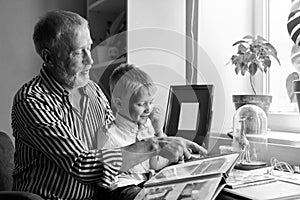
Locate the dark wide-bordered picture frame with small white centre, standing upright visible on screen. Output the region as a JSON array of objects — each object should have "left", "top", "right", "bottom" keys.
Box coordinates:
[{"left": 164, "top": 84, "right": 214, "bottom": 145}]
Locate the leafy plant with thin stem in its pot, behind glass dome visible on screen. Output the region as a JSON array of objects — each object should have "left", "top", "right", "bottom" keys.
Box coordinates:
[{"left": 229, "top": 35, "right": 280, "bottom": 114}]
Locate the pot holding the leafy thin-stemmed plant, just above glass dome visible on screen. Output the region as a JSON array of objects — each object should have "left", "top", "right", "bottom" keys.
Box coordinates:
[{"left": 232, "top": 95, "right": 274, "bottom": 115}]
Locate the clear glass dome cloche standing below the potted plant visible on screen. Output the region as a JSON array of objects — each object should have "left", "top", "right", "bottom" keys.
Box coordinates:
[{"left": 232, "top": 104, "right": 268, "bottom": 166}]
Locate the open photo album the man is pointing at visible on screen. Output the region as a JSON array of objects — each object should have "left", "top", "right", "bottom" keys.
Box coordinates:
[{"left": 135, "top": 153, "right": 239, "bottom": 200}]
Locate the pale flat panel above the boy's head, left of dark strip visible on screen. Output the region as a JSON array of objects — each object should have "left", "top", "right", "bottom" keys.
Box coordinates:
[{"left": 127, "top": 0, "right": 186, "bottom": 113}]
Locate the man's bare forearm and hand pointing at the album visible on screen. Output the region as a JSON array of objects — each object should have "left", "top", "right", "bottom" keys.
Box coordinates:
[{"left": 121, "top": 137, "right": 207, "bottom": 171}]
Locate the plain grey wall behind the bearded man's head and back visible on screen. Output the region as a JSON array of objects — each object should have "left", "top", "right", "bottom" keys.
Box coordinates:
[{"left": 0, "top": 0, "right": 86, "bottom": 141}]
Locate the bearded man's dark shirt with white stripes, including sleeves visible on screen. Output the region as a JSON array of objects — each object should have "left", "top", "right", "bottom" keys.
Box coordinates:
[{"left": 12, "top": 68, "right": 122, "bottom": 199}]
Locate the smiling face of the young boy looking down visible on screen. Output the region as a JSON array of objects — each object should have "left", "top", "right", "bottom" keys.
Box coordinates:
[{"left": 119, "top": 88, "right": 155, "bottom": 124}]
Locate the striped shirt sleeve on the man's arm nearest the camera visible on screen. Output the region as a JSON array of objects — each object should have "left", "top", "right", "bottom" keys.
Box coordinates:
[{"left": 12, "top": 97, "right": 122, "bottom": 185}]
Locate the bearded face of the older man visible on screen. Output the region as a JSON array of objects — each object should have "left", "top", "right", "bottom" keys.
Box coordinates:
[{"left": 56, "top": 27, "right": 93, "bottom": 89}]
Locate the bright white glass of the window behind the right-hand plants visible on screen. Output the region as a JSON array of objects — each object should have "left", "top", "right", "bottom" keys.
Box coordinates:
[{"left": 269, "top": 0, "right": 298, "bottom": 112}]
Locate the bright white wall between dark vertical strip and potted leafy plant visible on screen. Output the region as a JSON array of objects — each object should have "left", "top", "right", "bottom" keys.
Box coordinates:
[{"left": 198, "top": 0, "right": 253, "bottom": 131}]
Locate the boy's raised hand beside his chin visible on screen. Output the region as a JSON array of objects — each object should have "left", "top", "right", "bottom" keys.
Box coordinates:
[{"left": 149, "top": 105, "right": 164, "bottom": 137}]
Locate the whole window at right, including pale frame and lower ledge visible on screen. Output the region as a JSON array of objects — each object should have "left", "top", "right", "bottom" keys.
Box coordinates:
[{"left": 262, "top": 0, "right": 300, "bottom": 132}]
